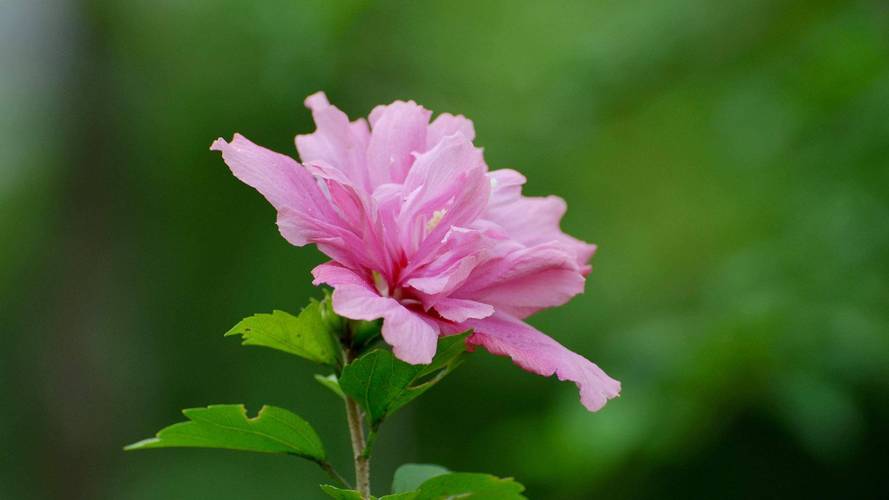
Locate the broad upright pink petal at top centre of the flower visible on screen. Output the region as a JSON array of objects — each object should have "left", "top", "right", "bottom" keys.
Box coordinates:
[{"left": 367, "top": 101, "right": 432, "bottom": 187}]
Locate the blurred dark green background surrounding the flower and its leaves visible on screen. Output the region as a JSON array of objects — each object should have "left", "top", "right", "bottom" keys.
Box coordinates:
[{"left": 0, "top": 0, "right": 889, "bottom": 499}]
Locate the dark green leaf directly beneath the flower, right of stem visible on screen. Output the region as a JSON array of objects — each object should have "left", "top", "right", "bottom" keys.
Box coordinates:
[{"left": 340, "top": 334, "right": 468, "bottom": 428}]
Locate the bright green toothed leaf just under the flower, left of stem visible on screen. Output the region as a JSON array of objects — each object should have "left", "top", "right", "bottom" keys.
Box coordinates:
[{"left": 225, "top": 299, "right": 339, "bottom": 366}]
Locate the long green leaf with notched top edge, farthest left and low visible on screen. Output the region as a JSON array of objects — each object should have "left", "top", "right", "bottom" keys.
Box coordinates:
[{"left": 124, "top": 405, "right": 325, "bottom": 462}]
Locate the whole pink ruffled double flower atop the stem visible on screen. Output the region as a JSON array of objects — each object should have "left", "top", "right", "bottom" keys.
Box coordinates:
[{"left": 210, "top": 92, "right": 620, "bottom": 411}]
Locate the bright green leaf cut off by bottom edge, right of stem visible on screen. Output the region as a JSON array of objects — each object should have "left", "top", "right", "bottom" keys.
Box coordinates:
[{"left": 414, "top": 472, "right": 525, "bottom": 500}]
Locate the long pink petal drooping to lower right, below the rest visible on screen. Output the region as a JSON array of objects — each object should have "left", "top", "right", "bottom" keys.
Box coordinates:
[{"left": 464, "top": 313, "right": 620, "bottom": 411}]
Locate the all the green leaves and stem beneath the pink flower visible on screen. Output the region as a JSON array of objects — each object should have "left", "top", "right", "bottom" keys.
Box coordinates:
[{"left": 124, "top": 296, "right": 492, "bottom": 500}]
